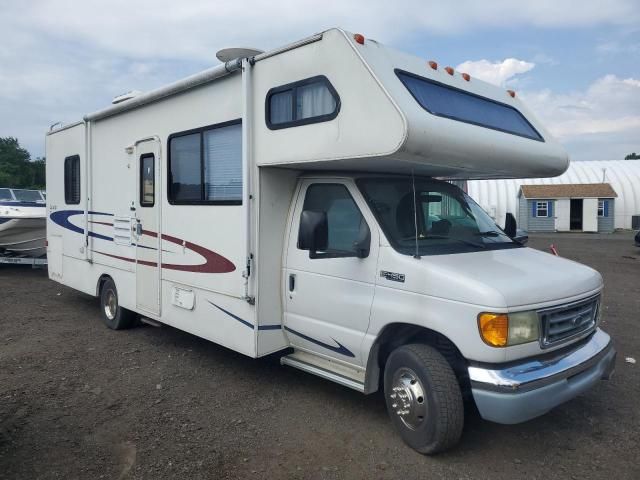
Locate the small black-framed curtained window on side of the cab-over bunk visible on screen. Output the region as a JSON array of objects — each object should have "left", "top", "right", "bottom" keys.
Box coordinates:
[{"left": 265, "top": 75, "right": 340, "bottom": 130}]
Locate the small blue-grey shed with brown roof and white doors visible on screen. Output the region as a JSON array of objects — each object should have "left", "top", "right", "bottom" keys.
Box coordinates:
[{"left": 518, "top": 183, "right": 618, "bottom": 233}]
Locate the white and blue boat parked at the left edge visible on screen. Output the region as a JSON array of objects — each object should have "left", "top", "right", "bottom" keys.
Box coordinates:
[{"left": 0, "top": 187, "right": 47, "bottom": 257}]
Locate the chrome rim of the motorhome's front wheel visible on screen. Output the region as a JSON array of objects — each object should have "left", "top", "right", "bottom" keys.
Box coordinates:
[{"left": 389, "top": 367, "right": 427, "bottom": 430}]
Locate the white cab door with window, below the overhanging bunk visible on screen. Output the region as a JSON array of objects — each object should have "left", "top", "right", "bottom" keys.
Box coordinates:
[{"left": 284, "top": 181, "right": 379, "bottom": 365}]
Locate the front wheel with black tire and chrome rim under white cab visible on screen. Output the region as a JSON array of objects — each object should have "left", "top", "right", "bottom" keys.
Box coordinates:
[{"left": 384, "top": 344, "right": 464, "bottom": 454}]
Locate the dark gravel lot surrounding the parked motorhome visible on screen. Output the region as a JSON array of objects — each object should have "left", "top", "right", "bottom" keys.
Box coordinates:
[{"left": 0, "top": 232, "right": 640, "bottom": 480}]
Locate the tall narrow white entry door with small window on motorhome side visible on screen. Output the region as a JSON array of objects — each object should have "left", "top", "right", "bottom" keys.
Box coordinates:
[{"left": 135, "top": 140, "right": 161, "bottom": 316}]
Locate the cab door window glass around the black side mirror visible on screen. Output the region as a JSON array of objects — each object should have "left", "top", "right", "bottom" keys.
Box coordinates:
[{"left": 303, "top": 183, "right": 369, "bottom": 258}]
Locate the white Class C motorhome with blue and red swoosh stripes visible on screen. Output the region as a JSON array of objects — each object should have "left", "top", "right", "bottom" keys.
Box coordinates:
[{"left": 47, "top": 29, "right": 615, "bottom": 453}]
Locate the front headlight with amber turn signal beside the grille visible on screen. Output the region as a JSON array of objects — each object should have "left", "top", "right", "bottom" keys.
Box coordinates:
[{"left": 478, "top": 311, "right": 540, "bottom": 347}]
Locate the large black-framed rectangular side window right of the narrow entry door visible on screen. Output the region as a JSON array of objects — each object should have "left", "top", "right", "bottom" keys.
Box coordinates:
[{"left": 168, "top": 120, "right": 242, "bottom": 205}]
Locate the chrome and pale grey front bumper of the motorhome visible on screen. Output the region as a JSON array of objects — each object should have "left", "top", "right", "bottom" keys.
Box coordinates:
[{"left": 469, "top": 328, "right": 616, "bottom": 424}]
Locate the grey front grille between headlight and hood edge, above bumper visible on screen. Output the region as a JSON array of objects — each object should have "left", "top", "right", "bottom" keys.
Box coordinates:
[{"left": 538, "top": 295, "right": 600, "bottom": 348}]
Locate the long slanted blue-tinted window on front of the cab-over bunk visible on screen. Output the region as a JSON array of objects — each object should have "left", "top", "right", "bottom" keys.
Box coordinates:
[{"left": 396, "top": 70, "right": 544, "bottom": 142}]
